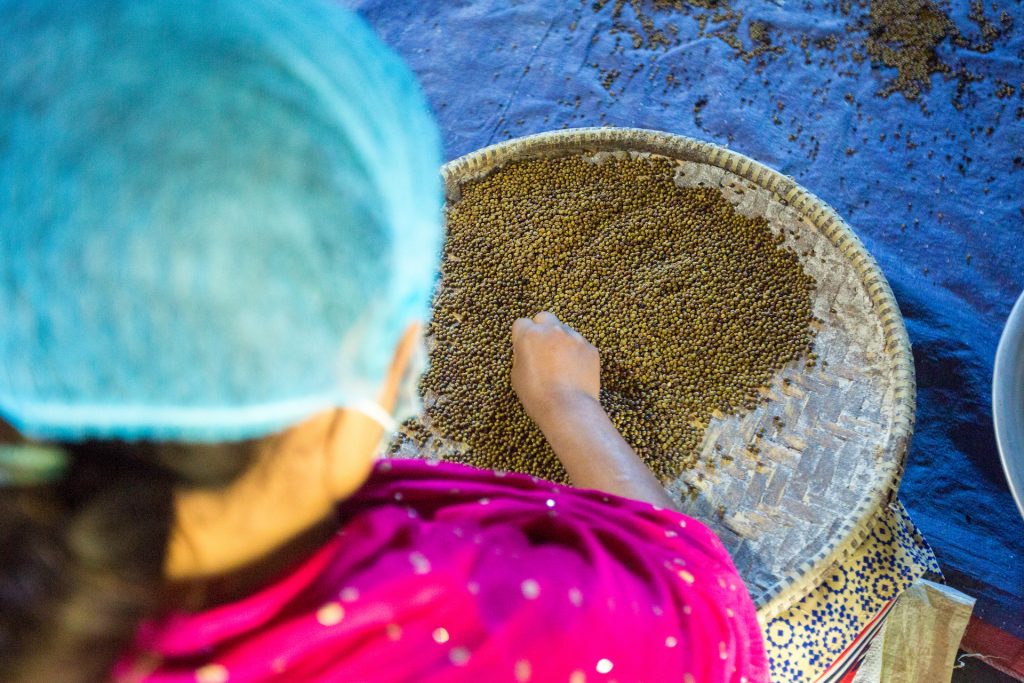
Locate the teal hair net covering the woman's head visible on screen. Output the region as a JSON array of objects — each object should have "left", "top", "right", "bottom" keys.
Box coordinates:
[{"left": 0, "top": 0, "right": 442, "bottom": 441}]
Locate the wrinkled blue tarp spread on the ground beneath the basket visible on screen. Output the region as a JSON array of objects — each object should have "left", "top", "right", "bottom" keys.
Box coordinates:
[{"left": 348, "top": 0, "right": 1024, "bottom": 637}]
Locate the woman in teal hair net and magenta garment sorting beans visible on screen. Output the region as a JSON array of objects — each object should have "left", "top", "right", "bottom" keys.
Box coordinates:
[{"left": 0, "top": 0, "right": 767, "bottom": 683}]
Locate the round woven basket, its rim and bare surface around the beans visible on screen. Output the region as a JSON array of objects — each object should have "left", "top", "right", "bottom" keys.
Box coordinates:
[{"left": 432, "top": 128, "right": 914, "bottom": 621}]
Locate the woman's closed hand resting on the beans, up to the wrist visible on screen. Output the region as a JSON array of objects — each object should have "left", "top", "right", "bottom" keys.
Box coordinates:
[{"left": 512, "top": 311, "right": 601, "bottom": 429}]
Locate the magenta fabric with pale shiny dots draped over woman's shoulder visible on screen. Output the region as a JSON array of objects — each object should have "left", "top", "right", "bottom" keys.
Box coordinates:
[{"left": 115, "top": 460, "right": 768, "bottom": 683}]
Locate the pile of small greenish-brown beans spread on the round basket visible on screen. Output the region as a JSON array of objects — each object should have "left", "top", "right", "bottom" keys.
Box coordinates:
[{"left": 407, "top": 157, "right": 814, "bottom": 481}]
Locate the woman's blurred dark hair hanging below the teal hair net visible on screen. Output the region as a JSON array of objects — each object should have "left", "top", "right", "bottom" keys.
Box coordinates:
[{"left": 0, "top": 424, "right": 256, "bottom": 683}]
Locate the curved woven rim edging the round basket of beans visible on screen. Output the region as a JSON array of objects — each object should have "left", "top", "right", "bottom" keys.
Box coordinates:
[{"left": 441, "top": 127, "right": 916, "bottom": 623}]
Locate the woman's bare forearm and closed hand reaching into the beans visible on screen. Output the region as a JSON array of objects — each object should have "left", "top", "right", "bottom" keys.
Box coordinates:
[{"left": 512, "top": 311, "right": 675, "bottom": 508}]
